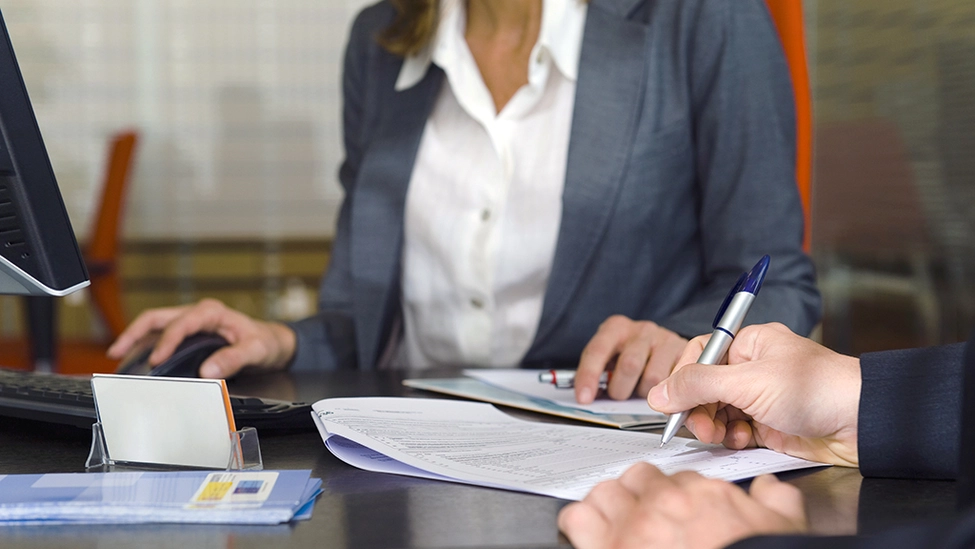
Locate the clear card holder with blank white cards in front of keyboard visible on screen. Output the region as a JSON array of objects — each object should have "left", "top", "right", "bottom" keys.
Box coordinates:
[{"left": 85, "top": 374, "right": 263, "bottom": 471}]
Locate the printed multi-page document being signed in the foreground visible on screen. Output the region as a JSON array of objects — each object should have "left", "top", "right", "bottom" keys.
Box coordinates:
[{"left": 312, "top": 397, "right": 822, "bottom": 500}]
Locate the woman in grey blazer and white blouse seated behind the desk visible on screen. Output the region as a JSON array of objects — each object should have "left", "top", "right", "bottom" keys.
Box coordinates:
[{"left": 110, "top": 0, "right": 820, "bottom": 400}]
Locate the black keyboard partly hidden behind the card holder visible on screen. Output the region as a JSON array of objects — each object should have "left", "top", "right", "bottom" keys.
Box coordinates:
[{"left": 0, "top": 368, "right": 315, "bottom": 432}]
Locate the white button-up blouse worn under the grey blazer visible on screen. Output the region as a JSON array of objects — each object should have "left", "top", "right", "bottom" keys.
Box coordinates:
[{"left": 393, "top": 0, "right": 586, "bottom": 368}]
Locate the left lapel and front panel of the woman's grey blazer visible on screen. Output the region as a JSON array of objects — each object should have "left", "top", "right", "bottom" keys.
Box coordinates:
[{"left": 350, "top": 60, "right": 443, "bottom": 369}]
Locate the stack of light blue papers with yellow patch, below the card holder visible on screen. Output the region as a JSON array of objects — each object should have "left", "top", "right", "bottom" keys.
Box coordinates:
[{"left": 0, "top": 470, "right": 322, "bottom": 525}]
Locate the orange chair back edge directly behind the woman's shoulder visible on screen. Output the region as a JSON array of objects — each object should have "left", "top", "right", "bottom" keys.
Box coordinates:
[{"left": 765, "top": 0, "right": 813, "bottom": 252}]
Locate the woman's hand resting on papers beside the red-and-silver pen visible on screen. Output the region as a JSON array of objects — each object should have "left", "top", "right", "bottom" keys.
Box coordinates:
[{"left": 575, "top": 315, "right": 687, "bottom": 404}]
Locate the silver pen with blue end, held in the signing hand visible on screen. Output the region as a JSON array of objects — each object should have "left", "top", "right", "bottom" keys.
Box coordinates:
[{"left": 660, "top": 255, "right": 769, "bottom": 446}]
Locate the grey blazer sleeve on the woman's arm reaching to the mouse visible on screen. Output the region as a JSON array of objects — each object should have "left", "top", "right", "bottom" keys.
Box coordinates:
[{"left": 290, "top": 4, "right": 392, "bottom": 370}]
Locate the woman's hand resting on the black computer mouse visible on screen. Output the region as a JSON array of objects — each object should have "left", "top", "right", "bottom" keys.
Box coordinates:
[{"left": 108, "top": 299, "right": 295, "bottom": 378}]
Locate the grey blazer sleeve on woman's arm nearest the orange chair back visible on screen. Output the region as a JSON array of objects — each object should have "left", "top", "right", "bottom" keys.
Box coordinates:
[{"left": 658, "top": 0, "right": 820, "bottom": 336}]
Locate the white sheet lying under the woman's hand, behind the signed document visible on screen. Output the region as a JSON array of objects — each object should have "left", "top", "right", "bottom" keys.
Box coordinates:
[{"left": 464, "top": 368, "right": 667, "bottom": 416}]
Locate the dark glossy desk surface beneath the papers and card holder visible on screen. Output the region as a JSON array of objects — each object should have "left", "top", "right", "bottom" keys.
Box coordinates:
[{"left": 0, "top": 372, "right": 954, "bottom": 549}]
